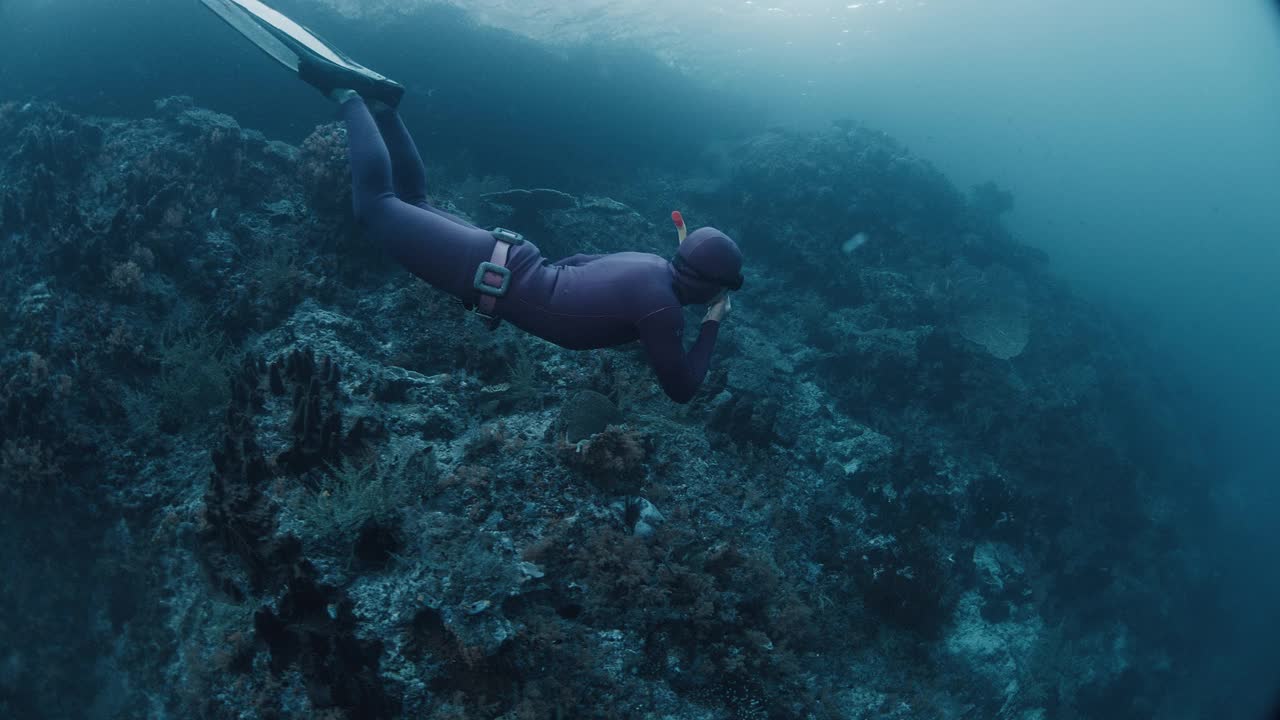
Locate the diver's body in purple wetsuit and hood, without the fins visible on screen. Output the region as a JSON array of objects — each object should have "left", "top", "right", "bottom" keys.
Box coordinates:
[{"left": 340, "top": 90, "right": 741, "bottom": 402}]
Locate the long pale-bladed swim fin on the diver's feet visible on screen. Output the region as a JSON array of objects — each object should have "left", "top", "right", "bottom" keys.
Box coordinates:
[{"left": 201, "top": 0, "right": 404, "bottom": 108}]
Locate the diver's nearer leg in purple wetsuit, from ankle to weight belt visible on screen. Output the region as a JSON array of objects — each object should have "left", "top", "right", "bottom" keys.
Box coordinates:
[{"left": 342, "top": 97, "right": 494, "bottom": 301}]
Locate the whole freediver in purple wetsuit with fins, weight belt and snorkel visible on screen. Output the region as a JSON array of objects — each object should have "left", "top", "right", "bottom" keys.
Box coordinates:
[{"left": 205, "top": 0, "right": 742, "bottom": 402}]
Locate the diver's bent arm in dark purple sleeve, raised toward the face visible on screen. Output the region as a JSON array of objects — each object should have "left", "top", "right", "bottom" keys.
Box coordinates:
[{"left": 639, "top": 306, "right": 719, "bottom": 404}]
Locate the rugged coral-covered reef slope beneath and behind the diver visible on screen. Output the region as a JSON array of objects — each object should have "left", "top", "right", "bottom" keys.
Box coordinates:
[{"left": 0, "top": 99, "right": 1212, "bottom": 720}]
